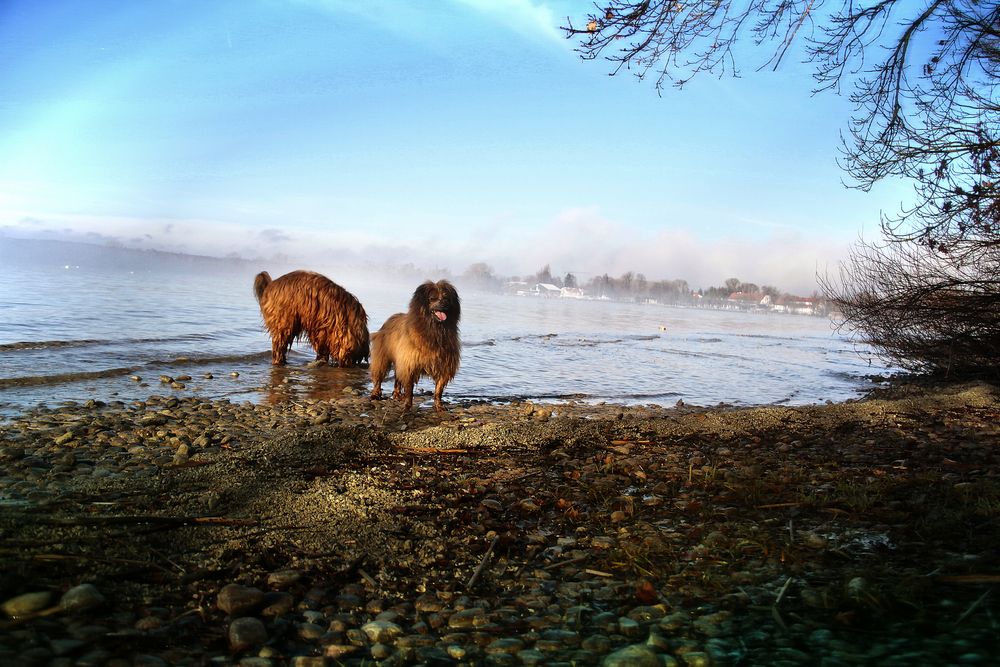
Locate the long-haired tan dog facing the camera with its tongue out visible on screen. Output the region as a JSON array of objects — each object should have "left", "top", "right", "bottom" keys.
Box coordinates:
[{"left": 371, "top": 280, "right": 462, "bottom": 412}]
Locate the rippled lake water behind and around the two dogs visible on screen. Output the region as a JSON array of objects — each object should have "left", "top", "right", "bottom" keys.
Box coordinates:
[{"left": 0, "top": 238, "right": 887, "bottom": 415}]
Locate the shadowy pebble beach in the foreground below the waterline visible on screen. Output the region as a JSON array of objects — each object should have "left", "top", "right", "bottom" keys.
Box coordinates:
[{"left": 0, "top": 384, "right": 1000, "bottom": 667}]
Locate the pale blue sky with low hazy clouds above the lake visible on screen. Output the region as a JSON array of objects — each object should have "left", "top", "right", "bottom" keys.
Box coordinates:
[{"left": 0, "top": 0, "right": 907, "bottom": 294}]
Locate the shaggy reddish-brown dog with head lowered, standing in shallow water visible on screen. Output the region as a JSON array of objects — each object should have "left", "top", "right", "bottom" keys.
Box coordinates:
[{"left": 253, "top": 271, "right": 368, "bottom": 368}]
